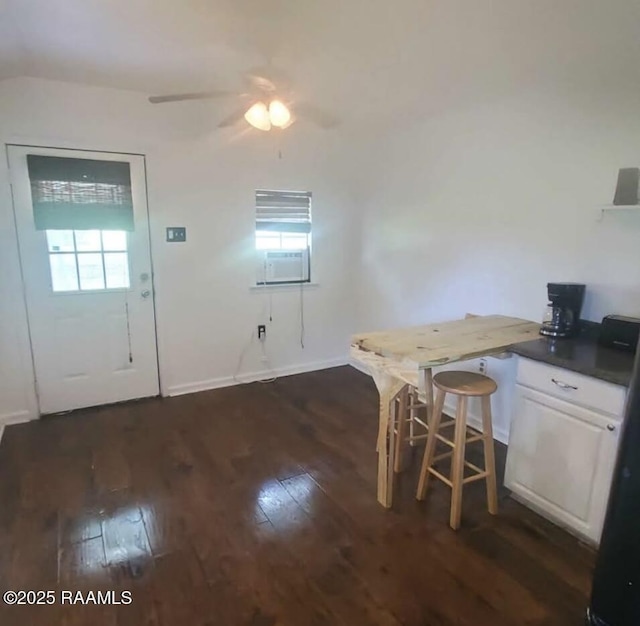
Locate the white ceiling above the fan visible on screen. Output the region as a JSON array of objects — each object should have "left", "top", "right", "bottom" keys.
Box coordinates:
[{"left": 0, "top": 0, "right": 640, "bottom": 127}]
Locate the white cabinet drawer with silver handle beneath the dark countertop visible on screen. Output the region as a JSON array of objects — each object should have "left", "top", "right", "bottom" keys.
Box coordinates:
[{"left": 517, "top": 357, "right": 626, "bottom": 418}]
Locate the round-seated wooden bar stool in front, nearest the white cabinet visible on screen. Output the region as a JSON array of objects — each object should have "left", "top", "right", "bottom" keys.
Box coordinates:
[{"left": 416, "top": 371, "right": 498, "bottom": 530}]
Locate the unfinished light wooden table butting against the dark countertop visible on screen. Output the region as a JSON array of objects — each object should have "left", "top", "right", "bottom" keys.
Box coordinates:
[{"left": 351, "top": 315, "right": 540, "bottom": 508}]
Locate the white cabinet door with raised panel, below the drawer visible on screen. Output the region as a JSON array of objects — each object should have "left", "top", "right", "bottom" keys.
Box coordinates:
[{"left": 505, "top": 385, "right": 620, "bottom": 542}]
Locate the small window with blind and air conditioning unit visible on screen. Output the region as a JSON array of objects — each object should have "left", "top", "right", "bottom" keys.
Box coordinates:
[{"left": 256, "top": 189, "right": 311, "bottom": 284}]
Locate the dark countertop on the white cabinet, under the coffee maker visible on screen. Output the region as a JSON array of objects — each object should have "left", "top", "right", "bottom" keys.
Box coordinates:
[{"left": 509, "top": 337, "right": 634, "bottom": 387}]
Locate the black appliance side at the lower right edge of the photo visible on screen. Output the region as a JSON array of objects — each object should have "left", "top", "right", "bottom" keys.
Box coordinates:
[{"left": 587, "top": 342, "right": 640, "bottom": 626}]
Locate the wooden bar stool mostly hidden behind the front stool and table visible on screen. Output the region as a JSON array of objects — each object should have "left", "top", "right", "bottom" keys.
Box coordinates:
[{"left": 393, "top": 369, "right": 433, "bottom": 473}]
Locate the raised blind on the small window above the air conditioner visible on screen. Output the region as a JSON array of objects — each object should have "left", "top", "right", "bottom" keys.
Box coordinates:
[{"left": 256, "top": 190, "right": 311, "bottom": 233}]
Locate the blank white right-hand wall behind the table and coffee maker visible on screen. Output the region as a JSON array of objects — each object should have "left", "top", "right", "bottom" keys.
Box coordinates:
[{"left": 358, "top": 93, "right": 640, "bottom": 329}]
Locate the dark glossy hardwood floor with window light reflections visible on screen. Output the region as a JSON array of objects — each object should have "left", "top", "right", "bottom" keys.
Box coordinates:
[{"left": 0, "top": 367, "right": 594, "bottom": 626}]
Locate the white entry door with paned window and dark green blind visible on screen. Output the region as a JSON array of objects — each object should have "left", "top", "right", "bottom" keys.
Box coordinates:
[{"left": 8, "top": 146, "right": 159, "bottom": 414}]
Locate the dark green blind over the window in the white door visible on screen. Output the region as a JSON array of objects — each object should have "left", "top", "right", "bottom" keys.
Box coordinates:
[{"left": 27, "top": 154, "right": 134, "bottom": 231}]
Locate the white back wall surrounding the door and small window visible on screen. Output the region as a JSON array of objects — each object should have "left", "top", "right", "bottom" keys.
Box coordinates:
[{"left": 0, "top": 79, "right": 356, "bottom": 423}]
